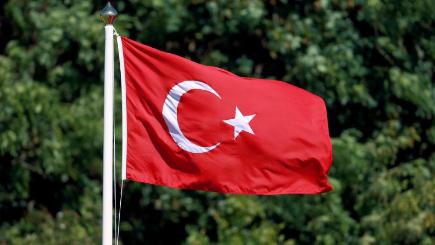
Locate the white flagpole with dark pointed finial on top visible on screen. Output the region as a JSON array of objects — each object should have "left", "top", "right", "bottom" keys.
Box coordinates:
[{"left": 100, "top": 2, "right": 118, "bottom": 245}]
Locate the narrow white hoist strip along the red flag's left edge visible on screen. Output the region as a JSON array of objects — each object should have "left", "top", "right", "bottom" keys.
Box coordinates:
[{"left": 116, "top": 35, "right": 127, "bottom": 180}]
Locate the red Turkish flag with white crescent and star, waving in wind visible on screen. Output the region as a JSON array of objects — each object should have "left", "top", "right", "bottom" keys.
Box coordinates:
[{"left": 117, "top": 37, "right": 332, "bottom": 195}]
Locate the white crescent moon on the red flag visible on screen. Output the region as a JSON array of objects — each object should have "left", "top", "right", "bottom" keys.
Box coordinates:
[{"left": 162, "top": 81, "right": 221, "bottom": 153}]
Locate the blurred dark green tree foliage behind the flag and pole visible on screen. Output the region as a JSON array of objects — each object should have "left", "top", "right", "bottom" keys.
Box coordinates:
[{"left": 0, "top": 0, "right": 435, "bottom": 244}]
